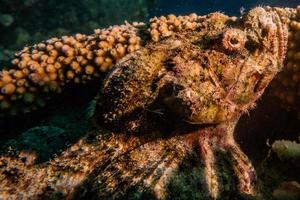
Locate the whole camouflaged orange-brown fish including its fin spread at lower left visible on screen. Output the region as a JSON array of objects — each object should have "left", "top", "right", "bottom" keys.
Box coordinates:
[{"left": 0, "top": 8, "right": 294, "bottom": 199}]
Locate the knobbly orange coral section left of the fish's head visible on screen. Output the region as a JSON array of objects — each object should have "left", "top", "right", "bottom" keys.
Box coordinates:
[{"left": 0, "top": 23, "right": 142, "bottom": 114}]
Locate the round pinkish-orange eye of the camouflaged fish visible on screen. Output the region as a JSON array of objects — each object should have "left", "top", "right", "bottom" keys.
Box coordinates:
[{"left": 222, "top": 28, "right": 247, "bottom": 51}]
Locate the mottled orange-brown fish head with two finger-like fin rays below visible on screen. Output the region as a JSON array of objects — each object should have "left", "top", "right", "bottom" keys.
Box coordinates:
[{"left": 102, "top": 7, "right": 288, "bottom": 198}]
